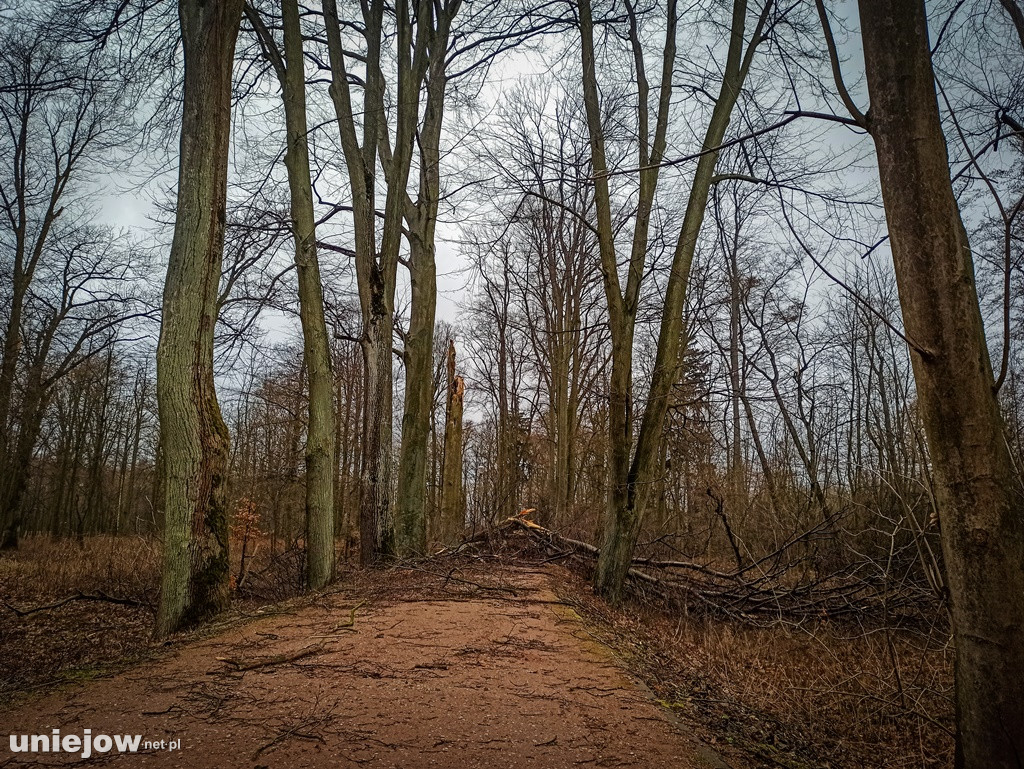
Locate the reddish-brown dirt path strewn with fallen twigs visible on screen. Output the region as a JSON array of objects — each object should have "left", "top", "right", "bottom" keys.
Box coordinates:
[{"left": 0, "top": 569, "right": 726, "bottom": 769}]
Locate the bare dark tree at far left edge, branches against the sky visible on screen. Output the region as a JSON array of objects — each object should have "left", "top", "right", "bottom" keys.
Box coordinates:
[{"left": 0, "top": 7, "right": 144, "bottom": 547}]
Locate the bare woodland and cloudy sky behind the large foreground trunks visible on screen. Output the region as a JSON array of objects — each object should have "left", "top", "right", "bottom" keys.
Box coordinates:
[{"left": 0, "top": 0, "right": 1024, "bottom": 764}]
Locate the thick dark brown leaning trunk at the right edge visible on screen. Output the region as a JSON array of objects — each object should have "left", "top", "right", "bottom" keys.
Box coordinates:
[{"left": 860, "top": 0, "right": 1024, "bottom": 769}]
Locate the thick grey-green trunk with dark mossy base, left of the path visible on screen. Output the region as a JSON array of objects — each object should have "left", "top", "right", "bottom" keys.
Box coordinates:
[{"left": 155, "top": 0, "right": 243, "bottom": 637}]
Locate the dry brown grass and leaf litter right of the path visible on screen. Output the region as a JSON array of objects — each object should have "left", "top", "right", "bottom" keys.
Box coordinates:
[{"left": 566, "top": 575, "right": 952, "bottom": 769}]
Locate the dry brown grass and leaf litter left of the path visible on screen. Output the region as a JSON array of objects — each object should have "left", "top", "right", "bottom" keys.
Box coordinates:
[{"left": 0, "top": 536, "right": 301, "bottom": 702}]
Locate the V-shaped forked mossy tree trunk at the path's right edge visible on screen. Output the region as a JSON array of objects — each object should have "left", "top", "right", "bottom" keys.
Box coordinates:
[{"left": 580, "top": 0, "right": 772, "bottom": 602}]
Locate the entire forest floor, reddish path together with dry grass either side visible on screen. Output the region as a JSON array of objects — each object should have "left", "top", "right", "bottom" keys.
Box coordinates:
[{"left": 0, "top": 537, "right": 952, "bottom": 769}]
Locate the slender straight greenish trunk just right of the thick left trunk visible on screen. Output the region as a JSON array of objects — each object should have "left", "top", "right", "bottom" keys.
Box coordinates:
[{"left": 281, "top": 0, "right": 336, "bottom": 590}]
